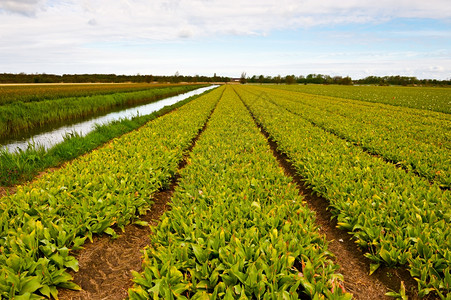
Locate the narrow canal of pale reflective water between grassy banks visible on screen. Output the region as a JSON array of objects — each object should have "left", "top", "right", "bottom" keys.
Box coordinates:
[{"left": 0, "top": 85, "right": 217, "bottom": 152}]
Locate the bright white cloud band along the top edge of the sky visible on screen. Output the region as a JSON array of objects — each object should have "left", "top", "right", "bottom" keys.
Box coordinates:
[{"left": 0, "top": 0, "right": 451, "bottom": 39}]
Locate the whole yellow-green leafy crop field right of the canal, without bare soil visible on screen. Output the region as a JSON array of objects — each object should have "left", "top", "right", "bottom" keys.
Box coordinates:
[{"left": 0, "top": 85, "right": 451, "bottom": 299}]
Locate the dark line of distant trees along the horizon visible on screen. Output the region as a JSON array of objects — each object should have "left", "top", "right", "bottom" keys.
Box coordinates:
[{"left": 0, "top": 72, "right": 451, "bottom": 86}]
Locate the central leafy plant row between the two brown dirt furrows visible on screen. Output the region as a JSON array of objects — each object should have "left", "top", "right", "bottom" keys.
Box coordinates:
[{"left": 129, "top": 87, "right": 351, "bottom": 299}]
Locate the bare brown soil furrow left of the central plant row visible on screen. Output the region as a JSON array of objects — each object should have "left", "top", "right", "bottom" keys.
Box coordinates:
[{"left": 59, "top": 182, "right": 175, "bottom": 300}]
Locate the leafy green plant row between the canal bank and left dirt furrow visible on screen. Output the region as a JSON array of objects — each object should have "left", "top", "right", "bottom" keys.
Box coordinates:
[{"left": 0, "top": 89, "right": 222, "bottom": 299}]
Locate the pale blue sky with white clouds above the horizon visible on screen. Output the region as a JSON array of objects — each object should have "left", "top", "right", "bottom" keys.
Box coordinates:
[{"left": 0, "top": 0, "right": 451, "bottom": 79}]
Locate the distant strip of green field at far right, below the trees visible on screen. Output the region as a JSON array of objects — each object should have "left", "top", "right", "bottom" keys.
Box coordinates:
[{"left": 266, "top": 84, "right": 451, "bottom": 114}]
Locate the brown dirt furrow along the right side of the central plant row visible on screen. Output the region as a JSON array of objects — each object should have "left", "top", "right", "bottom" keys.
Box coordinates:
[{"left": 231, "top": 91, "right": 432, "bottom": 300}]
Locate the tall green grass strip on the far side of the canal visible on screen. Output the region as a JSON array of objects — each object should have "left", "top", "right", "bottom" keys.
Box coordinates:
[{"left": 0, "top": 85, "right": 202, "bottom": 138}]
